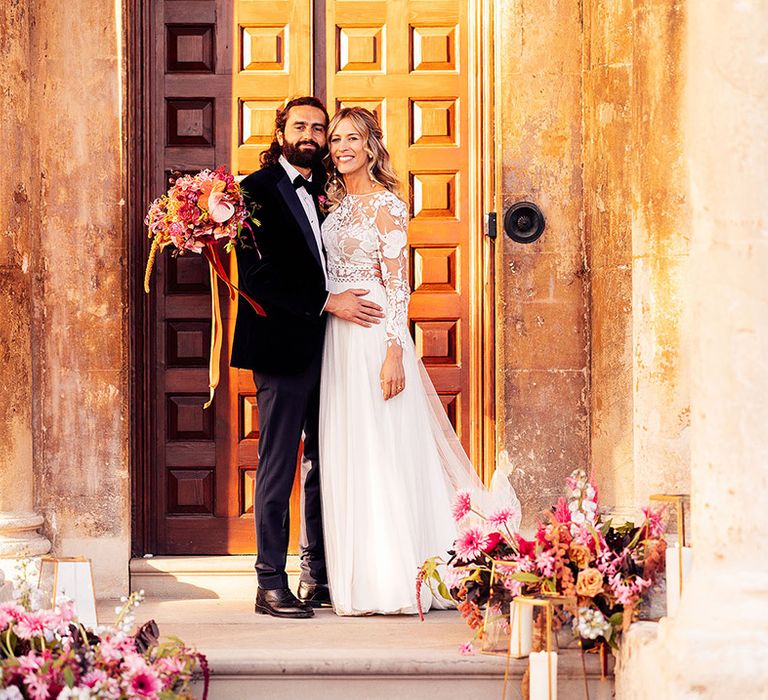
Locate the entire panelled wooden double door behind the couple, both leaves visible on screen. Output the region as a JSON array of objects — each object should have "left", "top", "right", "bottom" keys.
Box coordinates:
[{"left": 146, "top": 0, "right": 482, "bottom": 554}]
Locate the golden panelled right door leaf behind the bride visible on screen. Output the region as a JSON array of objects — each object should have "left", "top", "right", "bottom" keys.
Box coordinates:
[{"left": 326, "top": 0, "right": 479, "bottom": 457}]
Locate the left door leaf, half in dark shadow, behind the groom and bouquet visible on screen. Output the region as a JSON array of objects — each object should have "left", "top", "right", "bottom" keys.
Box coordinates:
[{"left": 148, "top": 0, "right": 312, "bottom": 554}]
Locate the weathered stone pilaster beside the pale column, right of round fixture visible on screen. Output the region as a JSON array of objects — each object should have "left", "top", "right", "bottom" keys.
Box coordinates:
[{"left": 584, "top": 0, "right": 690, "bottom": 512}]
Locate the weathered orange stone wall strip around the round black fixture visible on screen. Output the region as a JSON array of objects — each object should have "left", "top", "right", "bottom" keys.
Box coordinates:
[{"left": 496, "top": 0, "right": 589, "bottom": 524}]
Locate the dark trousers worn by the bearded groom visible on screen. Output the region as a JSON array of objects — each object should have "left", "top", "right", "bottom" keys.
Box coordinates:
[{"left": 253, "top": 354, "right": 328, "bottom": 588}]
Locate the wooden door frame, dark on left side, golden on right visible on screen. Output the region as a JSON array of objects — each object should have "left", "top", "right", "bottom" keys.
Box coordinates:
[{"left": 122, "top": 0, "right": 501, "bottom": 556}]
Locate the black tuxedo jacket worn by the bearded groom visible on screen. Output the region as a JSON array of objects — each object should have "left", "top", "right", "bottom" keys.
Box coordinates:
[{"left": 231, "top": 163, "right": 328, "bottom": 374}]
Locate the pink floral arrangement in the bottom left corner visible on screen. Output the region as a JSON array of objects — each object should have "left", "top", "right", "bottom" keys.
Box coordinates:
[{"left": 0, "top": 572, "right": 208, "bottom": 700}]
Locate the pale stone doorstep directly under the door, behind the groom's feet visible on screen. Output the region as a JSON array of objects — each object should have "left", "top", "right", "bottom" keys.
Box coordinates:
[{"left": 130, "top": 555, "right": 299, "bottom": 600}]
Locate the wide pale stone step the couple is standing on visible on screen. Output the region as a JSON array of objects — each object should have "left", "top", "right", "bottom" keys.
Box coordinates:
[{"left": 100, "top": 598, "right": 613, "bottom": 700}]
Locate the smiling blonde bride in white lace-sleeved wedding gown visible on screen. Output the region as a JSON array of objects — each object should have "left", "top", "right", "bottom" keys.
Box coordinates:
[{"left": 319, "top": 107, "right": 514, "bottom": 615}]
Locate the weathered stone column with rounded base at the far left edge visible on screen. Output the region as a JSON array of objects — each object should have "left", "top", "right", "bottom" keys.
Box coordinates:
[{"left": 0, "top": 3, "right": 50, "bottom": 558}]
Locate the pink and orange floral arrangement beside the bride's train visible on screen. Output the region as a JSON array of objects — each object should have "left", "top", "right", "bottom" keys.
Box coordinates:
[{"left": 417, "top": 470, "right": 666, "bottom": 652}]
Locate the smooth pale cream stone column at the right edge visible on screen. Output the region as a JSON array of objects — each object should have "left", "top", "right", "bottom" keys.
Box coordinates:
[{"left": 618, "top": 0, "right": 768, "bottom": 700}]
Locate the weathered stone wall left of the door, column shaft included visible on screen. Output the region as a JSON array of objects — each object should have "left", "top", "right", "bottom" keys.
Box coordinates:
[{"left": 0, "top": 0, "right": 130, "bottom": 594}]
